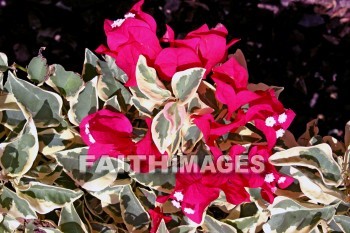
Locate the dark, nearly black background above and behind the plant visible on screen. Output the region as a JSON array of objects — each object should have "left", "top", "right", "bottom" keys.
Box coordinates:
[{"left": 0, "top": 0, "right": 350, "bottom": 138}]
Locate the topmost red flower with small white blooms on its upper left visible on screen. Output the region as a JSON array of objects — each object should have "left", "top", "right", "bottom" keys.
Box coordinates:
[{"left": 96, "top": 0, "right": 161, "bottom": 86}]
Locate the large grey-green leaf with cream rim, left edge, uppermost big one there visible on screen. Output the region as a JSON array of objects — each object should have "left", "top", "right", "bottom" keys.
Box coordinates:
[{"left": 5, "top": 72, "right": 63, "bottom": 128}]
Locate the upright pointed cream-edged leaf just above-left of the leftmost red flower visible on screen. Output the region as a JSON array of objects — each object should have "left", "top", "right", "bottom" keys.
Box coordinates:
[{"left": 68, "top": 77, "right": 98, "bottom": 126}]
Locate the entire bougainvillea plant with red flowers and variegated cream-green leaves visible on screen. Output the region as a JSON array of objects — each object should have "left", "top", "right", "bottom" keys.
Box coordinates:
[{"left": 0, "top": 1, "right": 350, "bottom": 233}]
